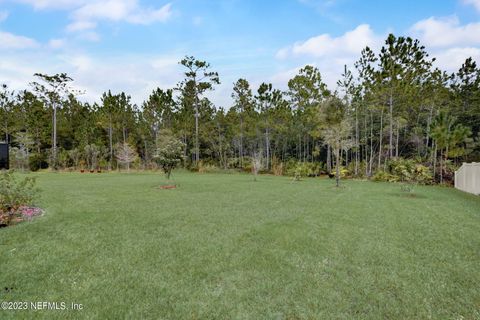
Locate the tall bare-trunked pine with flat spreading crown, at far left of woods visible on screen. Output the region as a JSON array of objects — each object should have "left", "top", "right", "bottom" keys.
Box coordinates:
[{"left": 31, "top": 73, "right": 78, "bottom": 169}]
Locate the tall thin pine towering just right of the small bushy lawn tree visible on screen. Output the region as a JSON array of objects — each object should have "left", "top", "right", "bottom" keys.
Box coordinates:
[{"left": 180, "top": 56, "right": 220, "bottom": 164}]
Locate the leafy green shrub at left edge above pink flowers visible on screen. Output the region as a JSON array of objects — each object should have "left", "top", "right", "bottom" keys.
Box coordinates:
[{"left": 0, "top": 171, "right": 38, "bottom": 226}]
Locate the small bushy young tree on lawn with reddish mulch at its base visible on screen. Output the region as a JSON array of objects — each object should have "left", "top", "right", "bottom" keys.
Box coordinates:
[{"left": 154, "top": 129, "right": 184, "bottom": 179}]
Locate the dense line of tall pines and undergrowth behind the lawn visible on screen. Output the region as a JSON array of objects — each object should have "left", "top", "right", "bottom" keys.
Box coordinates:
[{"left": 0, "top": 34, "right": 480, "bottom": 182}]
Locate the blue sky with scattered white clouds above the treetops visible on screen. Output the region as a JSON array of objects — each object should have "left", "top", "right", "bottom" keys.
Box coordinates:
[{"left": 0, "top": 0, "right": 480, "bottom": 108}]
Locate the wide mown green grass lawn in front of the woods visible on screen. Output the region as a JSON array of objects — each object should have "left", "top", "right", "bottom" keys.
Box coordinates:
[{"left": 0, "top": 173, "right": 480, "bottom": 319}]
